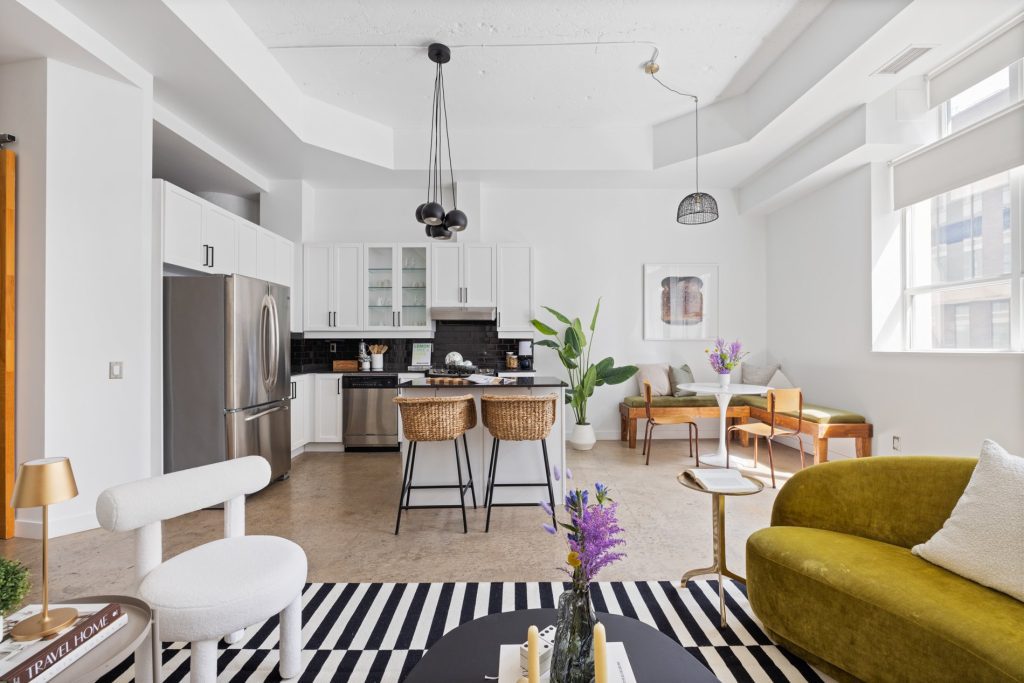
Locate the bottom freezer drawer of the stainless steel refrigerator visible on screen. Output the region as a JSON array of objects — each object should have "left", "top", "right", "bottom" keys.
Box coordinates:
[{"left": 224, "top": 398, "right": 292, "bottom": 480}]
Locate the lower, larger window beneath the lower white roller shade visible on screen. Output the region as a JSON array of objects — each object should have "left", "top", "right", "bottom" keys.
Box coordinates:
[{"left": 902, "top": 167, "right": 1024, "bottom": 351}]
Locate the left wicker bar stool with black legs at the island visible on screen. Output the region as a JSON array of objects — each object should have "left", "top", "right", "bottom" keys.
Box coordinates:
[{"left": 394, "top": 395, "right": 476, "bottom": 536}]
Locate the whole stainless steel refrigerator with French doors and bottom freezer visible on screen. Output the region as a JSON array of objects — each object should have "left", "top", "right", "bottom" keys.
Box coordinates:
[{"left": 164, "top": 275, "right": 292, "bottom": 479}]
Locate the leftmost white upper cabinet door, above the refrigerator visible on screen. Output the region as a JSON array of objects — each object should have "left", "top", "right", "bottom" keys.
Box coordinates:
[{"left": 153, "top": 180, "right": 209, "bottom": 270}]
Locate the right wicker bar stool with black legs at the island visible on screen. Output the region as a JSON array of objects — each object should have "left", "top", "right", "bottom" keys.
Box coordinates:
[{"left": 480, "top": 394, "right": 558, "bottom": 531}]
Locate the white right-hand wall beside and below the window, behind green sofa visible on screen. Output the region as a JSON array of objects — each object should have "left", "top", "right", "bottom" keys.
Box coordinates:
[{"left": 767, "top": 166, "right": 1024, "bottom": 455}]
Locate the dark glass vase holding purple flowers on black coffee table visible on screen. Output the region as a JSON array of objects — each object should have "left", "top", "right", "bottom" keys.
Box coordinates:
[{"left": 550, "top": 586, "right": 597, "bottom": 683}]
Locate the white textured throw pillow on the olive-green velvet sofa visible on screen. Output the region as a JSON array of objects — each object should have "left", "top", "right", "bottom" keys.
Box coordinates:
[{"left": 911, "top": 439, "right": 1024, "bottom": 600}]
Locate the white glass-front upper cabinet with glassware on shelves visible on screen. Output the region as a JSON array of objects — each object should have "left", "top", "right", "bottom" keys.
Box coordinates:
[{"left": 364, "top": 244, "right": 430, "bottom": 331}]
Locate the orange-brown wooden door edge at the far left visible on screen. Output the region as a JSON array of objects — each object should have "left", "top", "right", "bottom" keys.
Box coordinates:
[{"left": 0, "top": 148, "right": 16, "bottom": 539}]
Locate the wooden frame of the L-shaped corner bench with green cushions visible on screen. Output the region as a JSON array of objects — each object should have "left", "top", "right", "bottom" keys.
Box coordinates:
[{"left": 618, "top": 396, "right": 873, "bottom": 464}]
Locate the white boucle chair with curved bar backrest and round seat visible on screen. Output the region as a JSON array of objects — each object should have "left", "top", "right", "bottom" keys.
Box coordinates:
[{"left": 96, "top": 456, "right": 306, "bottom": 683}]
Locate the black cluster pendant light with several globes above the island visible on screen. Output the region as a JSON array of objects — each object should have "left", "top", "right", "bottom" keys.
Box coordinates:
[{"left": 416, "top": 43, "right": 469, "bottom": 240}]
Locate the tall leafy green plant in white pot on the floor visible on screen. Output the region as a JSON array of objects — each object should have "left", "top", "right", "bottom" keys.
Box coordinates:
[{"left": 530, "top": 299, "right": 638, "bottom": 451}]
